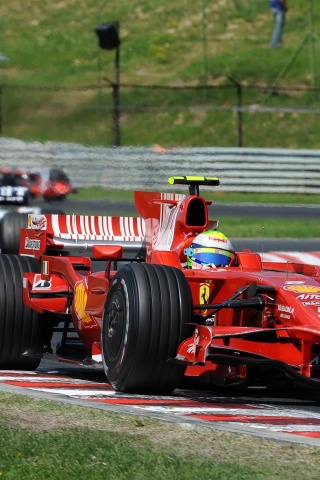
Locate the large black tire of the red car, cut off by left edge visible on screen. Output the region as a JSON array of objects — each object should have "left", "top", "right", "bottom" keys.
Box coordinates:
[{"left": 0, "top": 255, "right": 44, "bottom": 370}]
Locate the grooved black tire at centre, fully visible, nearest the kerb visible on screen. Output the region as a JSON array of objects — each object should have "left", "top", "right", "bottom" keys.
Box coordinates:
[{"left": 101, "top": 263, "right": 193, "bottom": 394}]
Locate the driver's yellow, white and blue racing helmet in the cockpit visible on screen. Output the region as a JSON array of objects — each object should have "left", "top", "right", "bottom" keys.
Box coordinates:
[{"left": 185, "top": 230, "right": 234, "bottom": 269}]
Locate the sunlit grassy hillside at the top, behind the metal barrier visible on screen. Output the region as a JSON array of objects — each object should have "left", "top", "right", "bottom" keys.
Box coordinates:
[{"left": 0, "top": 0, "right": 320, "bottom": 148}]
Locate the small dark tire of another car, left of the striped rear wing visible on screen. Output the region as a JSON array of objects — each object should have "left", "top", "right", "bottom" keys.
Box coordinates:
[{"left": 0, "top": 212, "right": 28, "bottom": 254}]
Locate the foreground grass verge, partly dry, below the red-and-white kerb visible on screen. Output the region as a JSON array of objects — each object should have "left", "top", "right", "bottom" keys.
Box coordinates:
[{"left": 0, "top": 393, "right": 319, "bottom": 480}]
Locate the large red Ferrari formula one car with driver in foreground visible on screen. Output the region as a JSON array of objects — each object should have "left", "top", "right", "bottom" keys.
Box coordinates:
[{"left": 0, "top": 177, "right": 320, "bottom": 393}]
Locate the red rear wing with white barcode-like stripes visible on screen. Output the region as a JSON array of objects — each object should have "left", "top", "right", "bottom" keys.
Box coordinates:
[{"left": 19, "top": 214, "right": 145, "bottom": 259}]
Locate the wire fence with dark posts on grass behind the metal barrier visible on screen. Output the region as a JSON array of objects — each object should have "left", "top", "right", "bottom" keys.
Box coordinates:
[{"left": 0, "top": 79, "right": 320, "bottom": 149}]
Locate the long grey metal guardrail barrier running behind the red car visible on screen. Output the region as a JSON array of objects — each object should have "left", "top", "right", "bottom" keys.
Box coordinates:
[{"left": 0, "top": 137, "right": 320, "bottom": 194}]
